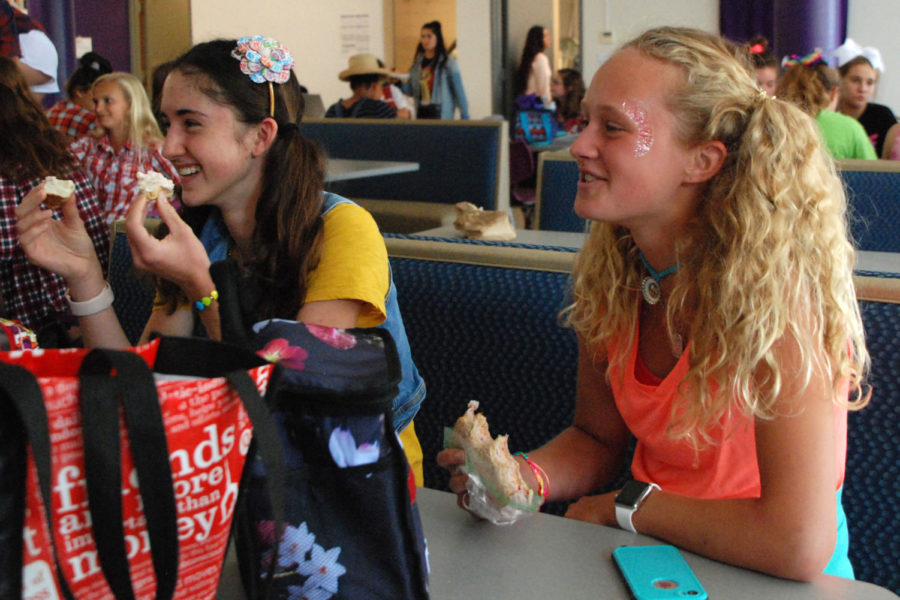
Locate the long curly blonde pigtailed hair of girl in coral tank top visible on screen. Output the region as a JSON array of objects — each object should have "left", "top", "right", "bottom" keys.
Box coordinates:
[{"left": 563, "top": 27, "right": 869, "bottom": 447}]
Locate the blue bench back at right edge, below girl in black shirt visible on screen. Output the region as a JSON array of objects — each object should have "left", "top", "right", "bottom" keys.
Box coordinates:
[{"left": 837, "top": 160, "right": 900, "bottom": 252}]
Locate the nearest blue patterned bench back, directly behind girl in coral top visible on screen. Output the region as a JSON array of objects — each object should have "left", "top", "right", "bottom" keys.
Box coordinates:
[{"left": 385, "top": 236, "right": 900, "bottom": 592}]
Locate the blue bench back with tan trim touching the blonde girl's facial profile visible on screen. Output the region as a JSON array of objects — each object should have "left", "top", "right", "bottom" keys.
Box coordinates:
[{"left": 535, "top": 150, "right": 587, "bottom": 232}]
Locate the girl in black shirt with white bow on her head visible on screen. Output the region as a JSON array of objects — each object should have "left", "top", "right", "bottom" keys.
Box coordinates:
[{"left": 834, "top": 38, "right": 897, "bottom": 157}]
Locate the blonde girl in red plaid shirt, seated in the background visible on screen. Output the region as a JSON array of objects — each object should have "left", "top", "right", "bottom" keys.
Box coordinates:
[{"left": 72, "top": 72, "right": 179, "bottom": 224}]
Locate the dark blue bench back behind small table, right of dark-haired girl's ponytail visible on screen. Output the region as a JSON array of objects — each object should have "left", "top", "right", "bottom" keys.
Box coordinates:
[{"left": 300, "top": 119, "right": 509, "bottom": 233}]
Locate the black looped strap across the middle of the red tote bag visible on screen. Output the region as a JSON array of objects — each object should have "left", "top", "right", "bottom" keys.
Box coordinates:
[{"left": 78, "top": 349, "right": 178, "bottom": 600}]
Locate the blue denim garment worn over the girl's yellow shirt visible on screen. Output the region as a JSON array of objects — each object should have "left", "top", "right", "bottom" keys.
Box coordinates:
[{"left": 197, "top": 192, "right": 425, "bottom": 433}]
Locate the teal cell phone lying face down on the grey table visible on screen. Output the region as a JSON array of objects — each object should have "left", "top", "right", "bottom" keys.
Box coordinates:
[{"left": 613, "top": 545, "right": 708, "bottom": 600}]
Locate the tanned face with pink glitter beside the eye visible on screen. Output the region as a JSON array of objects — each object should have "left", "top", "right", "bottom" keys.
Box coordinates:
[{"left": 571, "top": 49, "right": 698, "bottom": 231}]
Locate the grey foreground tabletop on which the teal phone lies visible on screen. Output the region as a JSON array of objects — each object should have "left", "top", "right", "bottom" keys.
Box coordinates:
[{"left": 417, "top": 488, "right": 897, "bottom": 600}]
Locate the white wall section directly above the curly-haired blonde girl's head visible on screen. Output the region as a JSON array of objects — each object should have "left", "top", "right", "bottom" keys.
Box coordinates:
[{"left": 581, "top": 0, "right": 720, "bottom": 77}]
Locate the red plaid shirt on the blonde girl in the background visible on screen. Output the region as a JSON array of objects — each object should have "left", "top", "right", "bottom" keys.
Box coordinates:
[{"left": 72, "top": 135, "right": 181, "bottom": 225}]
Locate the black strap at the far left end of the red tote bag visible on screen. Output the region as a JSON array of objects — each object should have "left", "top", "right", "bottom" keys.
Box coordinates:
[{"left": 0, "top": 363, "right": 73, "bottom": 600}]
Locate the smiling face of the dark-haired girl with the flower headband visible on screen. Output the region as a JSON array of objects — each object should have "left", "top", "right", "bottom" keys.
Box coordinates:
[{"left": 161, "top": 71, "right": 263, "bottom": 208}]
